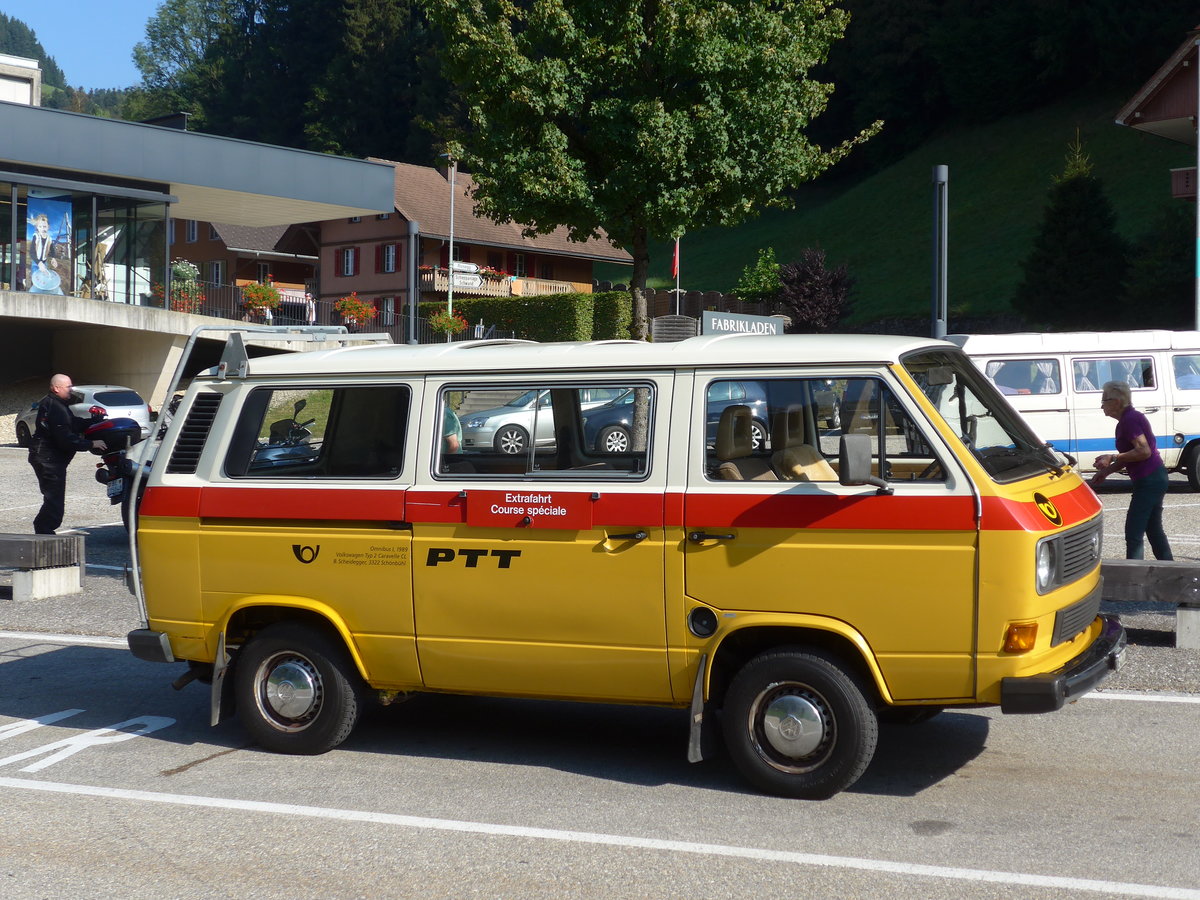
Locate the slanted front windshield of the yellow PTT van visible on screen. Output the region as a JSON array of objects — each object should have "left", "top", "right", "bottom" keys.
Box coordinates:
[{"left": 901, "top": 350, "right": 1073, "bottom": 484}]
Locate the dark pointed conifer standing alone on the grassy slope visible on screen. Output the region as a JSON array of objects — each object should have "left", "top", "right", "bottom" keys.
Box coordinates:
[{"left": 1013, "top": 137, "right": 1129, "bottom": 329}]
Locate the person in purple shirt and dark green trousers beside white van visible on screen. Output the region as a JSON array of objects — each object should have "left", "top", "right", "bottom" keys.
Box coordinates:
[{"left": 1092, "top": 382, "right": 1174, "bottom": 559}]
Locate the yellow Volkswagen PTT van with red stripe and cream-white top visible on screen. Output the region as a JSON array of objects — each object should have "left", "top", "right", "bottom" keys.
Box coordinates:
[{"left": 128, "top": 335, "right": 1124, "bottom": 798}]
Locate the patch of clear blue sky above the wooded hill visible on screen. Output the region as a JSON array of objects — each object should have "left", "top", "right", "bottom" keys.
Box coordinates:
[{"left": 0, "top": 0, "right": 162, "bottom": 89}]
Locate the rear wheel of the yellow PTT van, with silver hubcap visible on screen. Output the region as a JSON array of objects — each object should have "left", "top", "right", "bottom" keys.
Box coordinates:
[{"left": 233, "top": 623, "right": 362, "bottom": 756}]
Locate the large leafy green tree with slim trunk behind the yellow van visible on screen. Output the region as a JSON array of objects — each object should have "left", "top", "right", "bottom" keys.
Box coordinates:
[{"left": 422, "top": 0, "right": 874, "bottom": 338}]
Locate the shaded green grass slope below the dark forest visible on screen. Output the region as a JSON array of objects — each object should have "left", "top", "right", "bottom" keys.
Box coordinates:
[{"left": 596, "top": 90, "right": 1195, "bottom": 323}]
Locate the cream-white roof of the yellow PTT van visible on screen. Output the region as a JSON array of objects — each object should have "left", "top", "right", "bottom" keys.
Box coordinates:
[{"left": 216, "top": 335, "right": 953, "bottom": 377}]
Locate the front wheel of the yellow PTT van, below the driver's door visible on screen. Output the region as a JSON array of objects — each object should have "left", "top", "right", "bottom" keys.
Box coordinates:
[{"left": 721, "top": 648, "right": 880, "bottom": 800}]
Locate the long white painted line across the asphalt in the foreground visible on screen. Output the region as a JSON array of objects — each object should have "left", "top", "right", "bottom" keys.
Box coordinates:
[{"left": 0, "top": 778, "right": 1200, "bottom": 900}]
